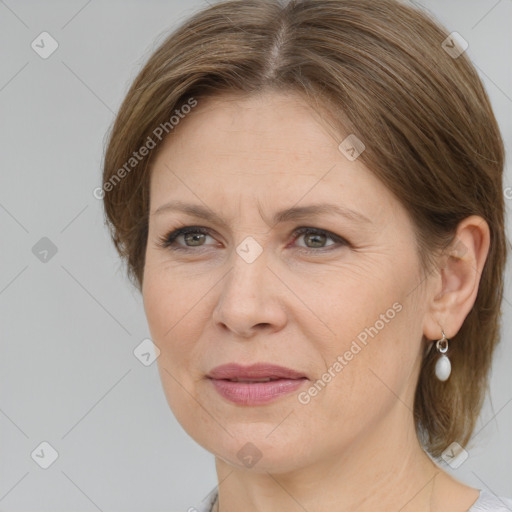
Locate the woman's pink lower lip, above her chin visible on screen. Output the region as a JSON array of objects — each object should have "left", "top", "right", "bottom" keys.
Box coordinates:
[{"left": 210, "top": 378, "right": 307, "bottom": 405}]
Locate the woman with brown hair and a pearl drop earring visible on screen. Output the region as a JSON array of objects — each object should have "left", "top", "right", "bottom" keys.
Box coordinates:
[{"left": 103, "top": 0, "right": 512, "bottom": 512}]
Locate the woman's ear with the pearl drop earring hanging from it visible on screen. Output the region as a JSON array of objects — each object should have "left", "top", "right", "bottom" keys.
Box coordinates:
[{"left": 423, "top": 215, "right": 490, "bottom": 340}]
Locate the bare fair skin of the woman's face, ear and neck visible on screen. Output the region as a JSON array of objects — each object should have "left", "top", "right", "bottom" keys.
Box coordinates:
[{"left": 142, "top": 91, "right": 489, "bottom": 512}]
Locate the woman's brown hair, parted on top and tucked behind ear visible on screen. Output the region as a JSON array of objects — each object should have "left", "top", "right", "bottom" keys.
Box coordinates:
[{"left": 103, "top": 0, "right": 507, "bottom": 456}]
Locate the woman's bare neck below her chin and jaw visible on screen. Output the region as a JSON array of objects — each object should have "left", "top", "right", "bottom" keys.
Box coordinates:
[{"left": 215, "top": 403, "right": 440, "bottom": 512}]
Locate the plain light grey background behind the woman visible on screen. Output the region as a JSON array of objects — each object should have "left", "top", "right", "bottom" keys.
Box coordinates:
[{"left": 0, "top": 0, "right": 512, "bottom": 512}]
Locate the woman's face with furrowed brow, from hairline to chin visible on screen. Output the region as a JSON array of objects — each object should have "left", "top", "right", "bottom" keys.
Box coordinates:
[{"left": 143, "top": 93, "right": 426, "bottom": 471}]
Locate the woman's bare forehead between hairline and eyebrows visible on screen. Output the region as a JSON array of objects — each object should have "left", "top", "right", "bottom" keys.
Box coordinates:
[{"left": 151, "top": 92, "right": 404, "bottom": 226}]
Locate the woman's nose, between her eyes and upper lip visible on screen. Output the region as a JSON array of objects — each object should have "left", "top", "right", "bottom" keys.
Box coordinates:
[{"left": 212, "top": 246, "right": 287, "bottom": 338}]
